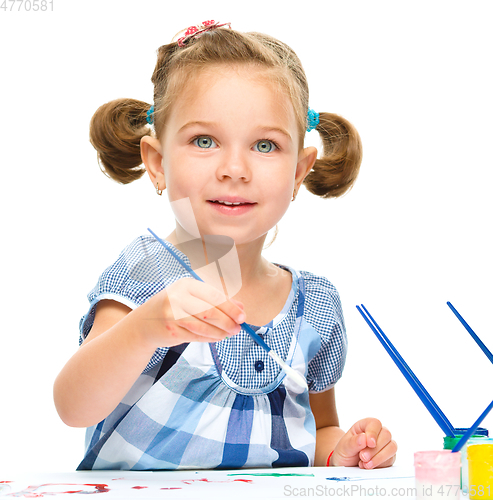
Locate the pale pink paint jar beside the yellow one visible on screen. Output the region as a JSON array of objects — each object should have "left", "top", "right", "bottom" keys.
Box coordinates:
[{"left": 414, "top": 450, "right": 461, "bottom": 500}]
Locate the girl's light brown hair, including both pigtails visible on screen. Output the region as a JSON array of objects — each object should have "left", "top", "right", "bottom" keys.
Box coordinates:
[{"left": 90, "top": 24, "right": 362, "bottom": 198}]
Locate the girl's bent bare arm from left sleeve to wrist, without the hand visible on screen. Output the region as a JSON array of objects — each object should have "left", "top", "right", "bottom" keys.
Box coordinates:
[{"left": 53, "top": 300, "right": 154, "bottom": 427}]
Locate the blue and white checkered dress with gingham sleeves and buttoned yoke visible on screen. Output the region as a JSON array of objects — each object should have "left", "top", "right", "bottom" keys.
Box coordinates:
[{"left": 78, "top": 236, "right": 347, "bottom": 470}]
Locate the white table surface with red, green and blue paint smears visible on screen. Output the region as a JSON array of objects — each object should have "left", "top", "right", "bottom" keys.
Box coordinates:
[{"left": 0, "top": 466, "right": 422, "bottom": 500}]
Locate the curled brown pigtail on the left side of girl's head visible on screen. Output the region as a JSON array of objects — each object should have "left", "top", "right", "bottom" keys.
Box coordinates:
[{"left": 89, "top": 99, "right": 151, "bottom": 184}]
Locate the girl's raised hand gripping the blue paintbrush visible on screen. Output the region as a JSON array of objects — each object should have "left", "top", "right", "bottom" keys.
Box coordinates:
[{"left": 134, "top": 278, "right": 246, "bottom": 349}]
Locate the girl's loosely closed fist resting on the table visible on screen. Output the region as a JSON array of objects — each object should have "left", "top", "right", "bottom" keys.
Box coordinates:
[{"left": 330, "top": 418, "right": 397, "bottom": 469}]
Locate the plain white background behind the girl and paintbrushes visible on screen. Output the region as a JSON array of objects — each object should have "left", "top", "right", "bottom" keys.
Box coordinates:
[{"left": 0, "top": 0, "right": 493, "bottom": 474}]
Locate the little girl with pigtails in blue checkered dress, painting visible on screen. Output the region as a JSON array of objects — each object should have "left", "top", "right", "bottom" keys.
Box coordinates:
[{"left": 54, "top": 21, "right": 397, "bottom": 470}]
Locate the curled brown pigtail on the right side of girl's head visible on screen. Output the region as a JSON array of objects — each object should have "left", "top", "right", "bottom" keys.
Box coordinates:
[{"left": 303, "top": 113, "right": 363, "bottom": 198}]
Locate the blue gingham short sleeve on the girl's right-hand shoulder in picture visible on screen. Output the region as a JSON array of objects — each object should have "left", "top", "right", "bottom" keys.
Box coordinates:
[{"left": 302, "top": 271, "right": 347, "bottom": 393}]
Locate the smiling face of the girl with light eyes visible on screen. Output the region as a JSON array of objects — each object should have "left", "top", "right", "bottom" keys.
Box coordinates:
[{"left": 161, "top": 66, "right": 316, "bottom": 245}]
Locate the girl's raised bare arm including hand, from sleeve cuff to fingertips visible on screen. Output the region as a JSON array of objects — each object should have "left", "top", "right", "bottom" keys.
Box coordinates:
[{"left": 53, "top": 279, "right": 244, "bottom": 427}]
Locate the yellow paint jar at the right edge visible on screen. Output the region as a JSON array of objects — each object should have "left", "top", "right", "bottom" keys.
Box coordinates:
[{"left": 467, "top": 443, "right": 493, "bottom": 500}]
